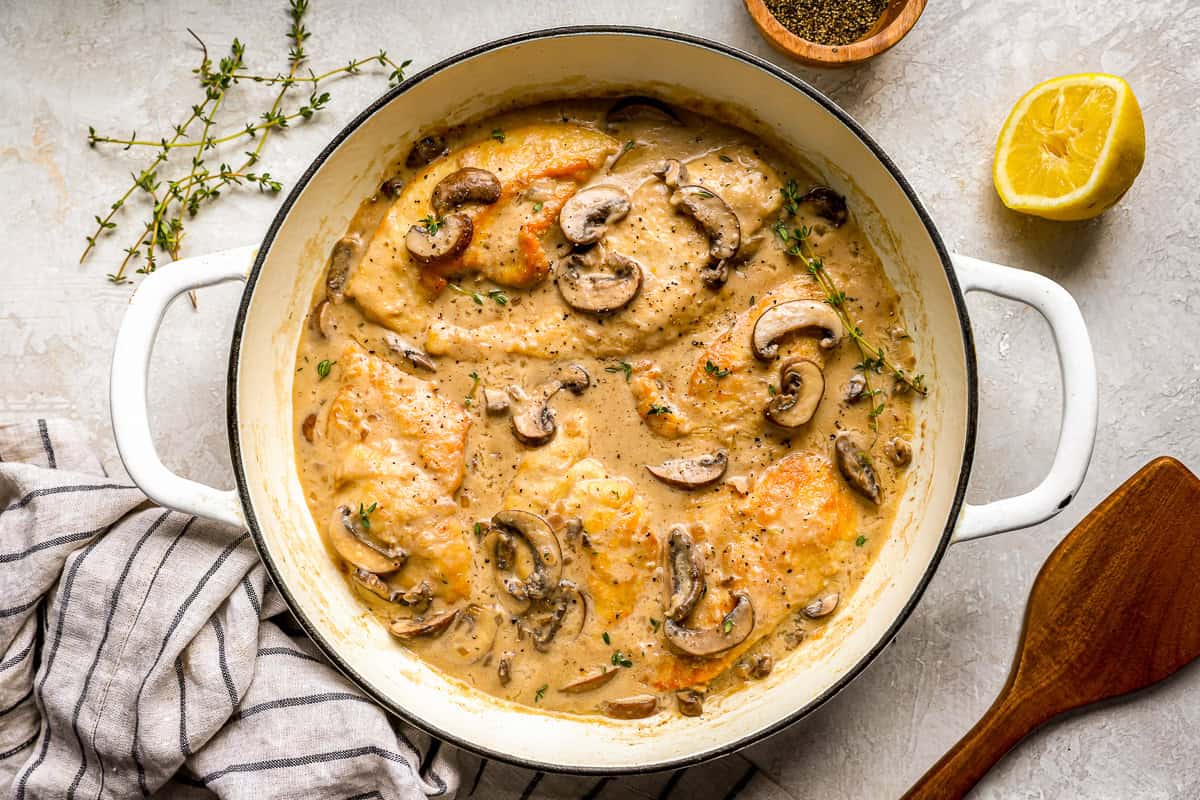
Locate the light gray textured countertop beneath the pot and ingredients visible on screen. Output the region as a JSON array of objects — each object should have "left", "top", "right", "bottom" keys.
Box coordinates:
[{"left": 0, "top": 0, "right": 1200, "bottom": 800}]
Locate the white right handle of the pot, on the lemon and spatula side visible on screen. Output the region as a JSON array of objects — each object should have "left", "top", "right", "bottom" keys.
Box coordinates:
[{"left": 952, "top": 254, "right": 1097, "bottom": 542}]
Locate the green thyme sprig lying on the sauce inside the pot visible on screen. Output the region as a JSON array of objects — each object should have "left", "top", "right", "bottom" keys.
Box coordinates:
[{"left": 772, "top": 180, "right": 929, "bottom": 433}]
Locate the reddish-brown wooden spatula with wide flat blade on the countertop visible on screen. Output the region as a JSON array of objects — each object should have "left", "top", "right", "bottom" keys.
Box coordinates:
[{"left": 905, "top": 458, "right": 1200, "bottom": 800}]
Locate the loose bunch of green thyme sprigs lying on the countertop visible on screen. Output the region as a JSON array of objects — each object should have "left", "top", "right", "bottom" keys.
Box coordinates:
[{"left": 79, "top": 0, "right": 409, "bottom": 287}]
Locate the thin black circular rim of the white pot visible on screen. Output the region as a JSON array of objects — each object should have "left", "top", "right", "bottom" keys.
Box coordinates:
[{"left": 226, "top": 25, "right": 978, "bottom": 776}]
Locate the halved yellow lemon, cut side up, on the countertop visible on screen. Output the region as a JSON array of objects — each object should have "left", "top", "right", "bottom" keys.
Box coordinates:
[{"left": 992, "top": 72, "right": 1146, "bottom": 219}]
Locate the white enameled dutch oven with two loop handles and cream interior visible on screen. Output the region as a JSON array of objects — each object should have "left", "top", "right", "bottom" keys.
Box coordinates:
[{"left": 112, "top": 28, "right": 1097, "bottom": 774}]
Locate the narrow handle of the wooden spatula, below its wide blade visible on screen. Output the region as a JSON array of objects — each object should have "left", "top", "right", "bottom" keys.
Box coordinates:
[{"left": 904, "top": 687, "right": 1048, "bottom": 800}]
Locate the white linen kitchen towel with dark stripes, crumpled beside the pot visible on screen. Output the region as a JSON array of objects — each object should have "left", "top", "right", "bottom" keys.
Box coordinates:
[{"left": 0, "top": 420, "right": 788, "bottom": 800}]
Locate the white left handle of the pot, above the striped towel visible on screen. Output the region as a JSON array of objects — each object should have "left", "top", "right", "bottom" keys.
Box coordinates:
[{"left": 109, "top": 246, "right": 258, "bottom": 528}]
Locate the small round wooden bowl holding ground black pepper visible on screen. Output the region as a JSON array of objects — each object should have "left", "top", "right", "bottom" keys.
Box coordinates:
[{"left": 745, "top": 0, "right": 925, "bottom": 67}]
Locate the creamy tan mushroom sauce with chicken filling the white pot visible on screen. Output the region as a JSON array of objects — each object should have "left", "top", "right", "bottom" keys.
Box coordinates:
[{"left": 294, "top": 100, "right": 914, "bottom": 718}]
